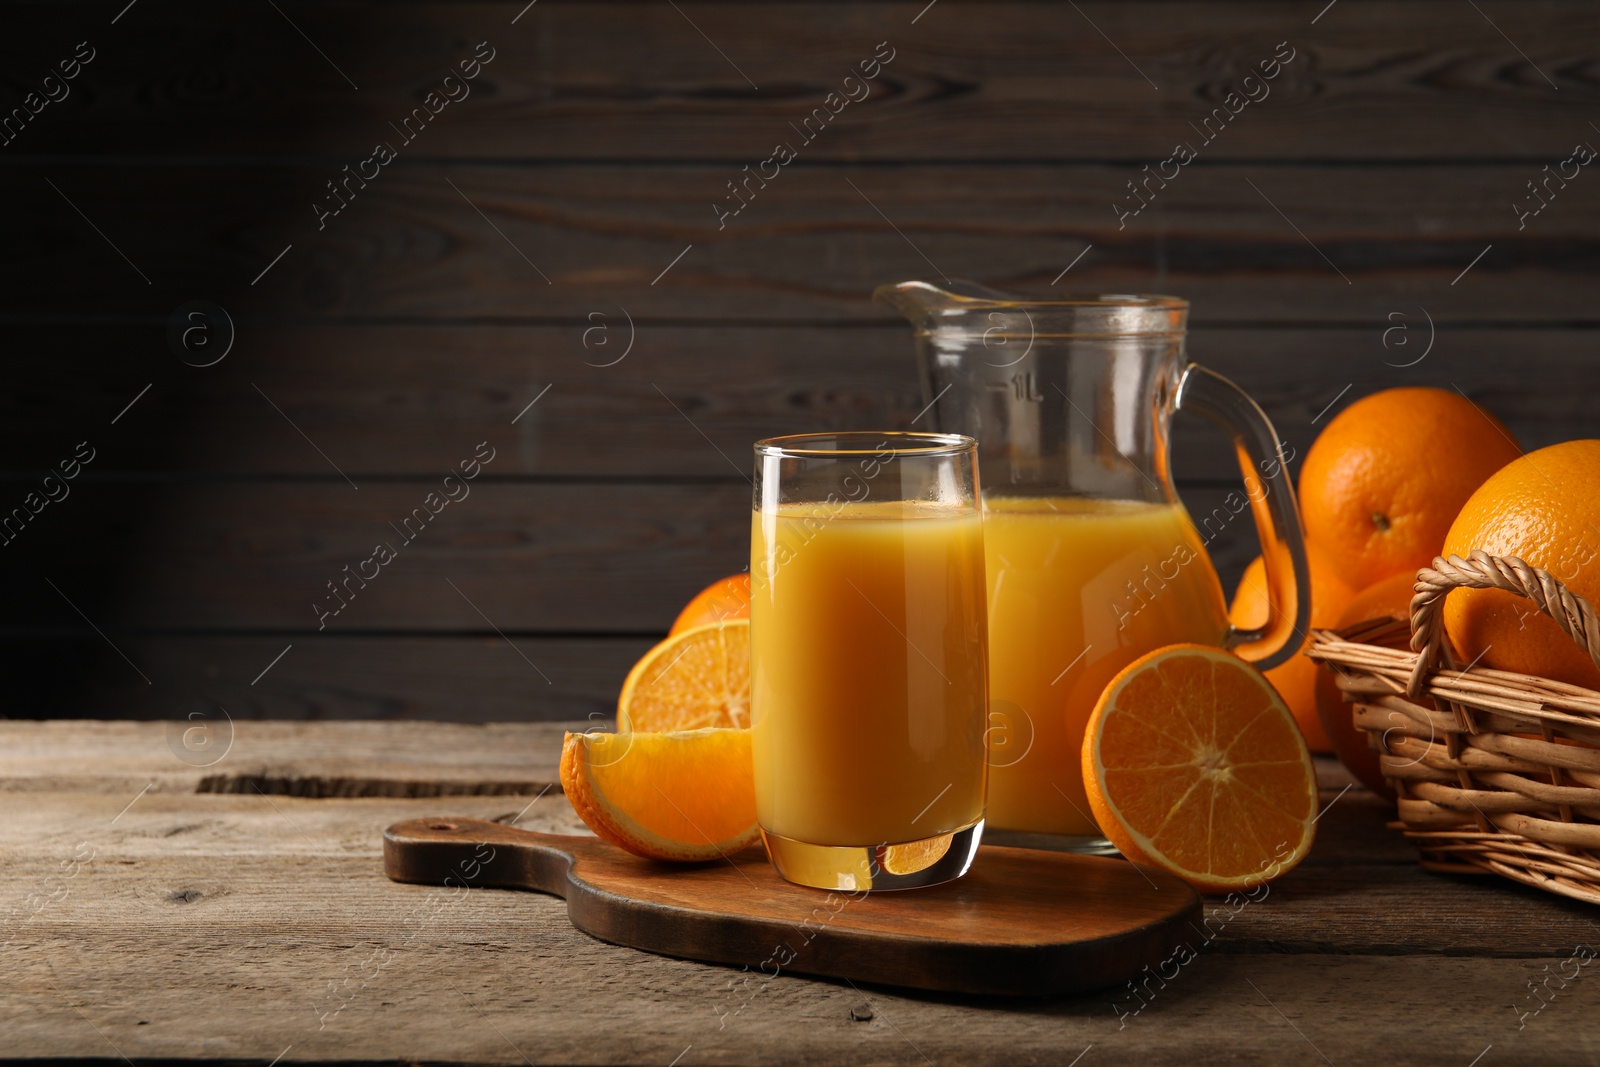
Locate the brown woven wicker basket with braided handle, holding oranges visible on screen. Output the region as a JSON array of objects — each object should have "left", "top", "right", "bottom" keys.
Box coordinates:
[{"left": 1306, "top": 552, "right": 1600, "bottom": 904}]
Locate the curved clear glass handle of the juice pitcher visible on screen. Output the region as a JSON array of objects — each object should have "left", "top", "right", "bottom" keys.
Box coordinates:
[{"left": 1173, "top": 363, "right": 1310, "bottom": 670}]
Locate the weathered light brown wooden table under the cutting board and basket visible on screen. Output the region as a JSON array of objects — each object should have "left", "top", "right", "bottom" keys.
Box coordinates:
[{"left": 0, "top": 721, "right": 1600, "bottom": 1067}]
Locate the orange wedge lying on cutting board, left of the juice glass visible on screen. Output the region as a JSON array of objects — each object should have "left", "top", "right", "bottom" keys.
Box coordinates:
[{"left": 562, "top": 729, "right": 760, "bottom": 862}]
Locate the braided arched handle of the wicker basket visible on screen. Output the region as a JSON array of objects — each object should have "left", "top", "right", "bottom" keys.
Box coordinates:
[{"left": 1406, "top": 549, "right": 1600, "bottom": 699}]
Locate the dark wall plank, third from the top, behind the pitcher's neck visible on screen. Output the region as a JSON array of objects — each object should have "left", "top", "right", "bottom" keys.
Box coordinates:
[{"left": 0, "top": 323, "right": 1600, "bottom": 476}]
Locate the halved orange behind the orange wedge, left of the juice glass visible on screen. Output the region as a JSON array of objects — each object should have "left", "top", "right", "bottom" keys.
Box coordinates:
[{"left": 616, "top": 619, "right": 750, "bottom": 733}]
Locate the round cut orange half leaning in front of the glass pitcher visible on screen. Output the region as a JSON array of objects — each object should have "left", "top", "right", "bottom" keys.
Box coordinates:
[{"left": 1083, "top": 645, "right": 1317, "bottom": 893}]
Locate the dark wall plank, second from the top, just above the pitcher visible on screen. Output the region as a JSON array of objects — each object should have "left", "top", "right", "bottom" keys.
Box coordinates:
[{"left": 0, "top": 163, "right": 1600, "bottom": 321}]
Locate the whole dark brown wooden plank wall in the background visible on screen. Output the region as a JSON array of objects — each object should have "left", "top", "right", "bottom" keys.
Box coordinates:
[{"left": 0, "top": 0, "right": 1600, "bottom": 720}]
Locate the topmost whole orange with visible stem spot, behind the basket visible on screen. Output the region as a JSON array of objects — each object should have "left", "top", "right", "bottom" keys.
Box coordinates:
[{"left": 1299, "top": 389, "right": 1522, "bottom": 589}]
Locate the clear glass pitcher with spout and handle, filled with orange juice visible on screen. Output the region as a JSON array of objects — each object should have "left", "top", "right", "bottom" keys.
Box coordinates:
[{"left": 874, "top": 280, "right": 1310, "bottom": 851}]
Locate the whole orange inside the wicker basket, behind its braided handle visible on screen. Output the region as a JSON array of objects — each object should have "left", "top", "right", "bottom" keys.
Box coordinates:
[{"left": 1443, "top": 440, "right": 1600, "bottom": 689}]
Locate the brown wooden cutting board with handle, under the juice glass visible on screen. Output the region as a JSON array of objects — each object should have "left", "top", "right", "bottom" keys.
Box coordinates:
[{"left": 384, "top": 819, "right": 1200, "bottom": 997}]
